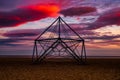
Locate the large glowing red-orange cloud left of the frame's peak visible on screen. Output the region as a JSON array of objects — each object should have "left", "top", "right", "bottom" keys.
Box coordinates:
[{"left": 0, "top": 4, "right": 60, "bottom": 27}]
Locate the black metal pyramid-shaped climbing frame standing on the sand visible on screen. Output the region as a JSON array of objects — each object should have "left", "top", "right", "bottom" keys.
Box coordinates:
[{"left": 32, "top": 17, "right": 86, "bottom": 63}]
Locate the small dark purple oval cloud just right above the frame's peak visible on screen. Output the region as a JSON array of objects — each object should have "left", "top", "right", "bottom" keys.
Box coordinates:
[{"left": 60, "top": 7, "right": 96, "bottom": 16}]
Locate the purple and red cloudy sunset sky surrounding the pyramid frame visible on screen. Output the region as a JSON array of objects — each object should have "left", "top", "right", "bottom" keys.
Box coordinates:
[{"left": 0, "top": 0, "right": 120, "bottom": 56}]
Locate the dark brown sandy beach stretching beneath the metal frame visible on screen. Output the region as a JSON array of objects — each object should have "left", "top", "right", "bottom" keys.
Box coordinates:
[{"left": 0, "top": 58, "right": 120, "bottom": 80}]
